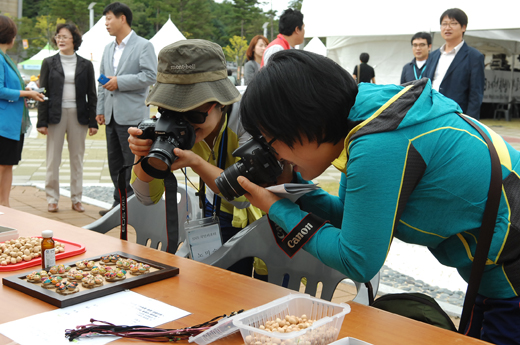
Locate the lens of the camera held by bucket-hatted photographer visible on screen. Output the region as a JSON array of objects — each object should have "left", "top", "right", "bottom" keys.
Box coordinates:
[{"left": 141, "top": 137, "right": 178, "bottom": 179}]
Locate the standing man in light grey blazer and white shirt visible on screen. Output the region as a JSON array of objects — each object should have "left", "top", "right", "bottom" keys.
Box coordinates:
[{"left": 96, "top": 2, "right": 157, "bottom": 215}]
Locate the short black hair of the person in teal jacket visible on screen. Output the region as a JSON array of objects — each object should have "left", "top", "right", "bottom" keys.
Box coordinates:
[{"left": 240, "top": 49, "right": 358, "bottom": 147}]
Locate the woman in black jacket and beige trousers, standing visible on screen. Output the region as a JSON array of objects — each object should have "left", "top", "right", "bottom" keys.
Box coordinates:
[{"left": 37, "top": 23, "right": 98, "bottom": 212}]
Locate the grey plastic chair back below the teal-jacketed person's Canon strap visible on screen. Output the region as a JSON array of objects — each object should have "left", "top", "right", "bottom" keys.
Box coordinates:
[{"left": 202, "top": 216, "right": 379, "bottom": 305}]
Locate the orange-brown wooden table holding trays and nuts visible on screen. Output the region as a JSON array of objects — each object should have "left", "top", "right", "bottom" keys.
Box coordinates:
[{"left": 0, "top": 206, "right": 490, "bottom": 345}]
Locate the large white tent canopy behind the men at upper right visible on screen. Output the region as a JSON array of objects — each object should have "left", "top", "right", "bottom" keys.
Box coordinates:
[{"left": 302, "top": 0, "right": 520, "bottom": 84}]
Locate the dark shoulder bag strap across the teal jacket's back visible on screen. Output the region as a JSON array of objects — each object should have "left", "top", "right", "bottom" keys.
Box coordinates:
[{"left": 458, "top": 114, "right": 502, "bottom": 334}]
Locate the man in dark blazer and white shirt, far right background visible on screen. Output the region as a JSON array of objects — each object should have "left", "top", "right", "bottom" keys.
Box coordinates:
[{"left": 425, "top": 8, "right": 484, "bottom": 119}]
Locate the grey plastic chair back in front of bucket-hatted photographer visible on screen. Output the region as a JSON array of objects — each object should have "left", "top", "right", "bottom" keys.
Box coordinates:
[{"left": 83, "top": 185, "right": 202, "bottom": 251}]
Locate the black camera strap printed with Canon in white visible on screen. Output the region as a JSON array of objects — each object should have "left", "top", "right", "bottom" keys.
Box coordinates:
[{"left": 267, "top": 213, "right": 329, "bottom": 258}]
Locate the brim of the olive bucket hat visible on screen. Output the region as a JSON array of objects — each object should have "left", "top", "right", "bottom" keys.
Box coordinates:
[{"left": 146, "top": 78, "right": 240, "bottom": 111}]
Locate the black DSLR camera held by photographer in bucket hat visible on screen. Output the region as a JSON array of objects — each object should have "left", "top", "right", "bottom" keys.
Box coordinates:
[{"left": 137, "top": 109, "right": 195, "bottom": 179}]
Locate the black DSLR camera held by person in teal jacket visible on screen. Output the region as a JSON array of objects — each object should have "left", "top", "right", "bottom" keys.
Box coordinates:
[{"left": 215, "top": 137, "right": 283, "bottom": 201}]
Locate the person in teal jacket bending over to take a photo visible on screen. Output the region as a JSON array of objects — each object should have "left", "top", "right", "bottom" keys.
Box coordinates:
[{"left": 238, "top": 50, "right": 520, "bottom": 344}]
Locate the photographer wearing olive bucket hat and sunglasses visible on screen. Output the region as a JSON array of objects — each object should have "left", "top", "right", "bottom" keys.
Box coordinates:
[{"left": 128, "top": 39, "right": 261, "bottom": 276}]
